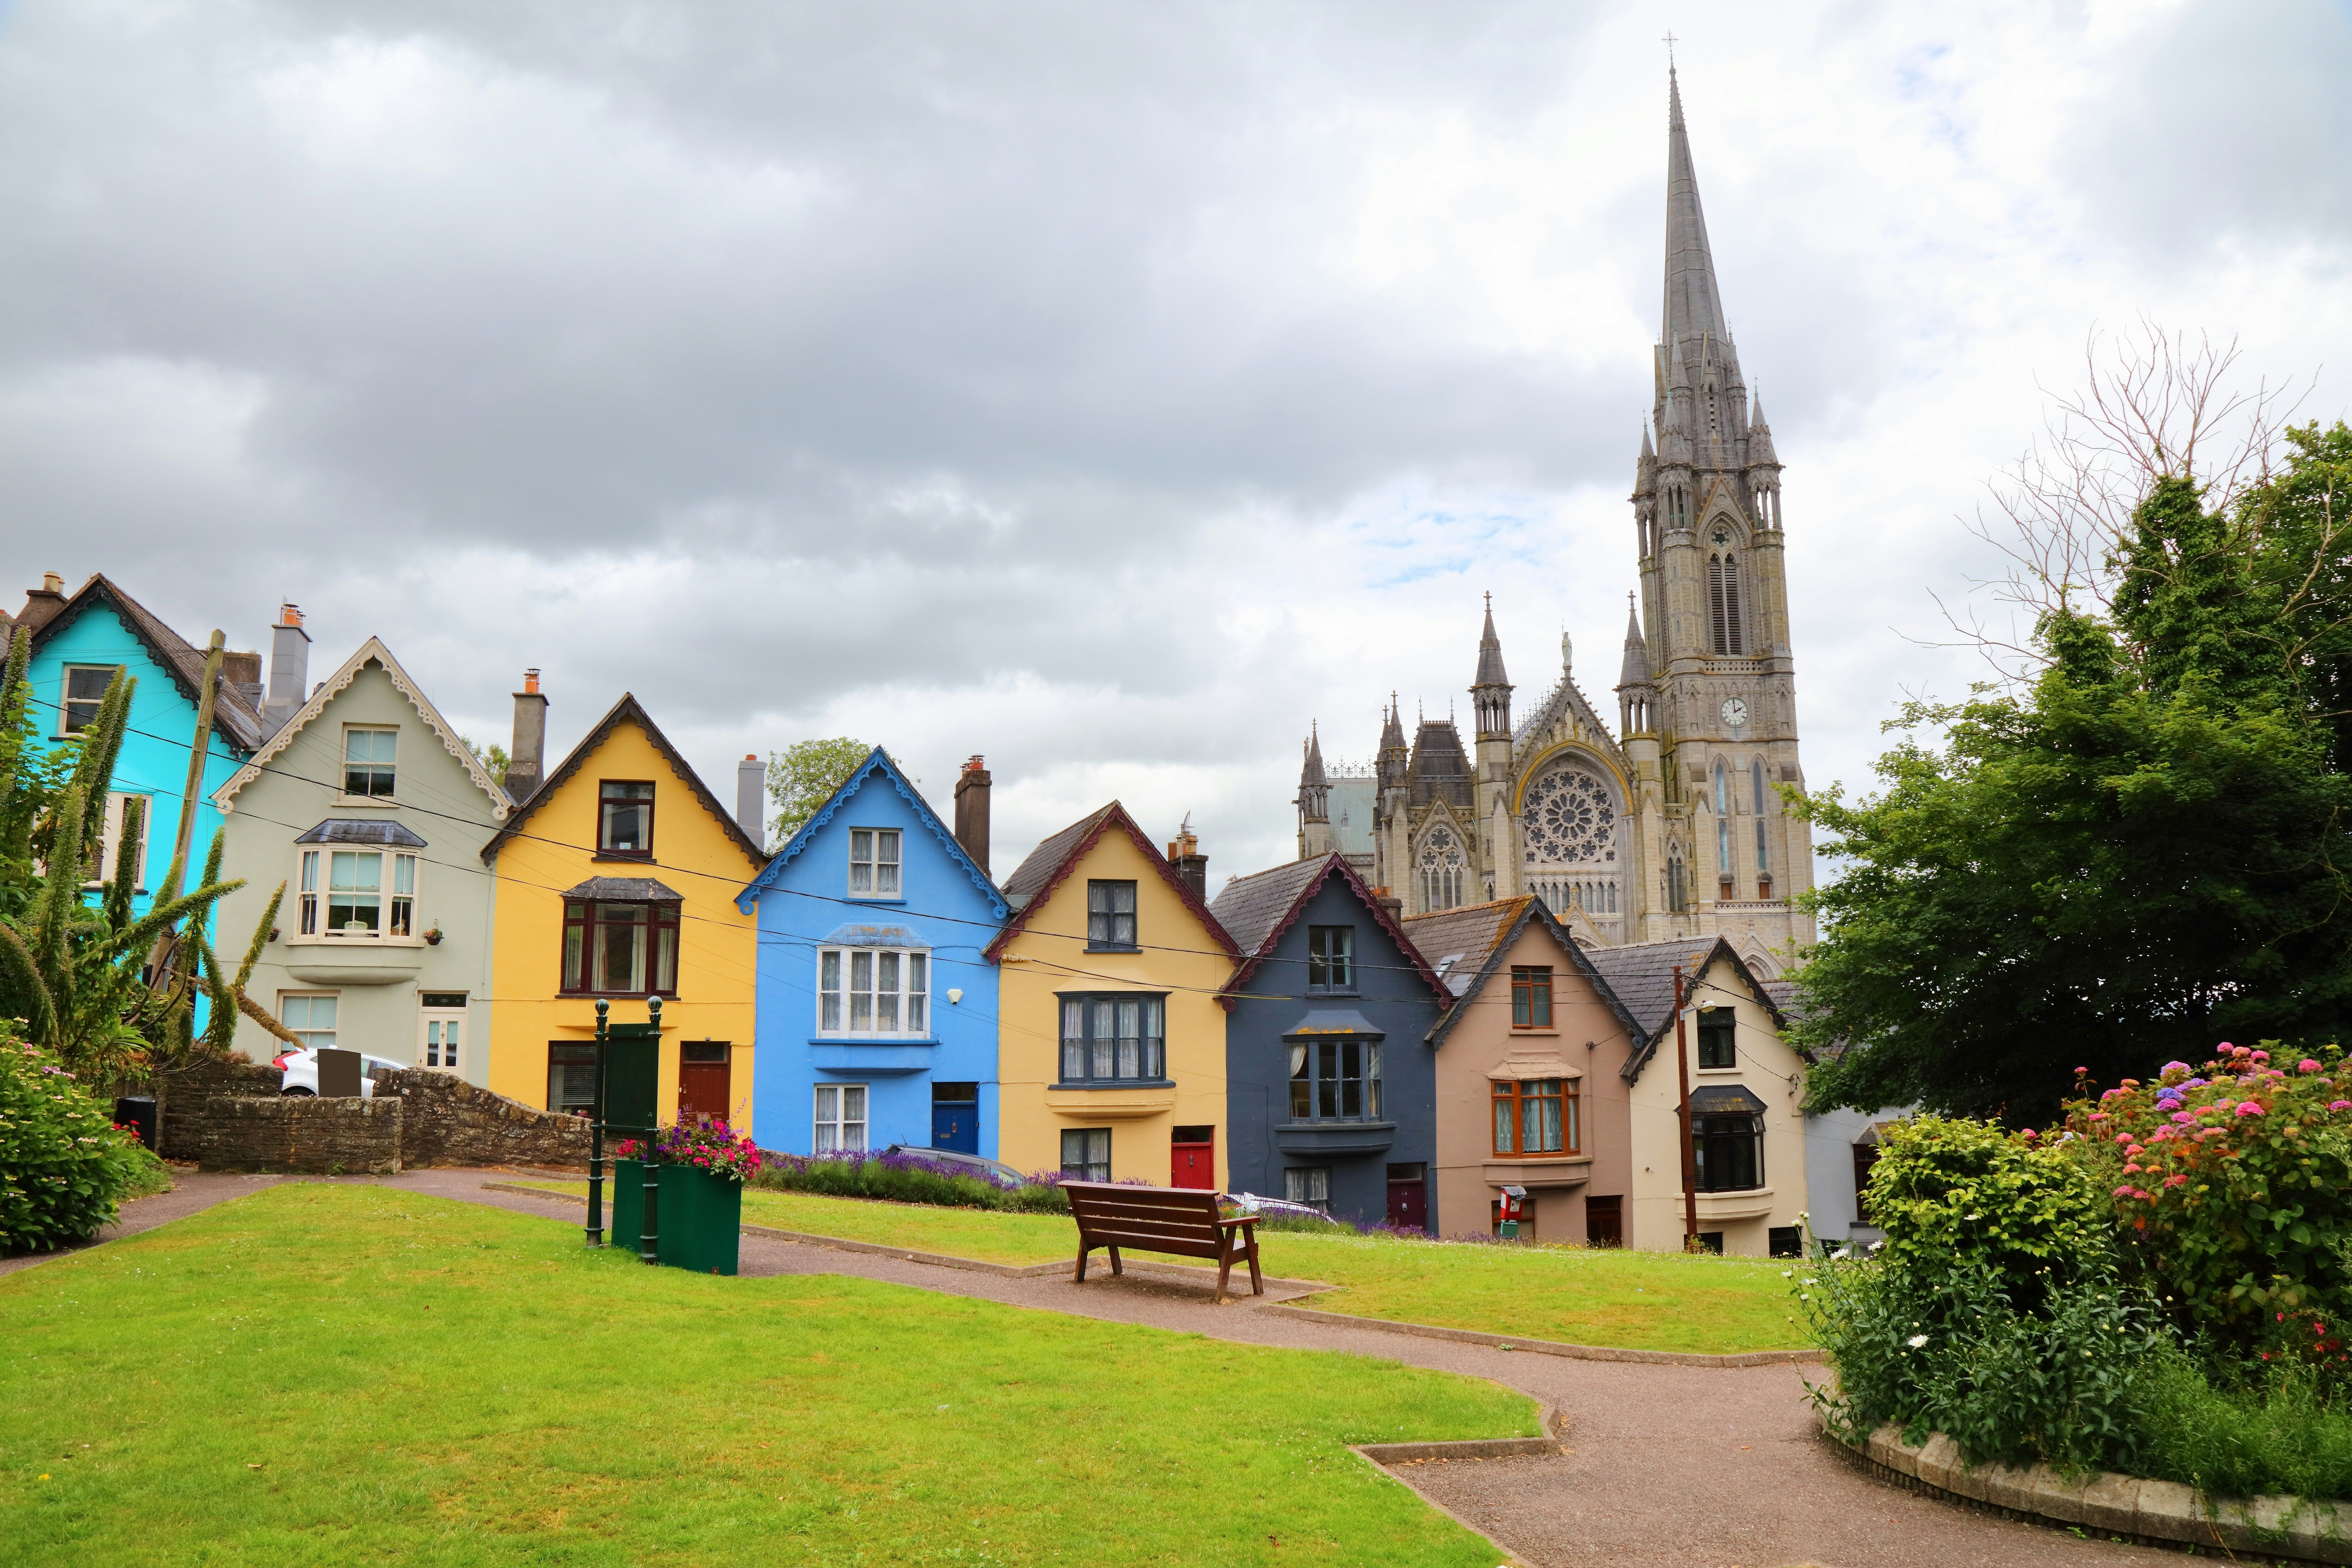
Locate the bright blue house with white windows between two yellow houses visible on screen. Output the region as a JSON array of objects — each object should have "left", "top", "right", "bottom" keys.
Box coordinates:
[{"left": 736, "top": 748, "right": 1009, "bottom": 1159}]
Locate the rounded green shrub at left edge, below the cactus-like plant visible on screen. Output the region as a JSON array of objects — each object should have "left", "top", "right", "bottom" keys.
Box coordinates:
[{"left": 0, "top": 1023, "right": 139, "bottom": 1253}]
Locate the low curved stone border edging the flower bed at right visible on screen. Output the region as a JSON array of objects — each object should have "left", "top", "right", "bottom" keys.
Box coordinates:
[{"left": 1823, "top": 1422, "right": 2352, "bottom": 1563}]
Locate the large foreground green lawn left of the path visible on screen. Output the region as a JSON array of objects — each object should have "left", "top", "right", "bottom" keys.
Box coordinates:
[{"left": 0, "top": 1182, "right": 1536, "bottom": 1568}]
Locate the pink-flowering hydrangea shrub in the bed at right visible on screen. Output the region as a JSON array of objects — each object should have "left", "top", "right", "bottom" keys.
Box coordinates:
[{"left": 2067, "top": 1044, "right": 2352, "bottom": 1363}]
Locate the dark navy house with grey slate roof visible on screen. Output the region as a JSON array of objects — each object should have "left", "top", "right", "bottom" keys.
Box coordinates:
[{"left": 1209, "top": 856, "right": 1454, "bottom": 1229}]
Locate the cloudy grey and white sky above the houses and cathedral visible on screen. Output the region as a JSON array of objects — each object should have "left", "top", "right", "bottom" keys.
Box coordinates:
[{"left": 0, "top": 0, "right": 2352, "bottom": 882}]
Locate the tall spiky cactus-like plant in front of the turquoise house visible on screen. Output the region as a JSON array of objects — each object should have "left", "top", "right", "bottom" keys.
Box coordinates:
[{"left": 0, "top": 635, "right": 285, "bottom": 1084}]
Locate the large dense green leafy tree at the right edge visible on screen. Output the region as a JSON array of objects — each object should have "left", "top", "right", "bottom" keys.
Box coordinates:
[{"left": 1792, "top": 475, "right": 2352, "bottom": 1121}]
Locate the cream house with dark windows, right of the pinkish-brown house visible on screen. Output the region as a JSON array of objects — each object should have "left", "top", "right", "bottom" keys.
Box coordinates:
[{"left": 1585, "top": 935, "right": 1806, "bottom": 1258}]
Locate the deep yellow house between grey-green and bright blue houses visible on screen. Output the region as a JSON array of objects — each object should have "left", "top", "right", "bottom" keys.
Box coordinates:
[{"left": 482, "top": 691, "right": 767, "bottom": 1133}]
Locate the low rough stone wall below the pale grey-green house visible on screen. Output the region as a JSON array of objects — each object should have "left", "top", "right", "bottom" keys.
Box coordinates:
[{"left": 155, "top": 1060, "right": 588, "bottom": 1173}]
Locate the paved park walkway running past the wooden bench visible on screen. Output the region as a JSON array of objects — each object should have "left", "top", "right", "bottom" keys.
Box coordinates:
[{"left": 14, "top": 1171, "right": 2180, "bottom": 1568}]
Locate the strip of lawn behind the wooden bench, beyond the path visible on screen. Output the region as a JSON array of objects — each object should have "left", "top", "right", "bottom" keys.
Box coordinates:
[{"left": 510, "top": 1182, "right": 1804, "bottom": 1354}]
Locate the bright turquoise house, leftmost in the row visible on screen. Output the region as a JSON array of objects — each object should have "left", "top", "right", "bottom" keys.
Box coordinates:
[{"left": 16, "top": 574, "right": 266, "bottom": 921}]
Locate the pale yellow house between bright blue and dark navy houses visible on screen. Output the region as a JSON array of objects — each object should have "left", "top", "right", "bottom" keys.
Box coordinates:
[{"left": 988, "top": 801, "right": 1242, "bottom": 1192}]
